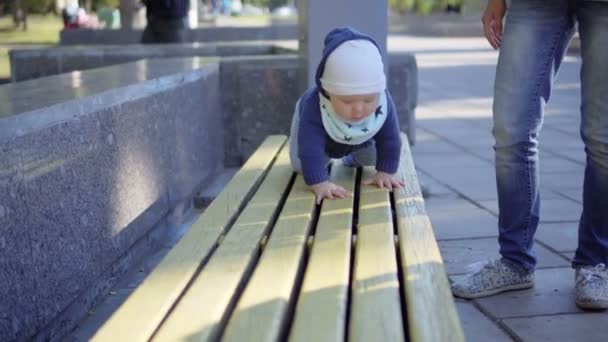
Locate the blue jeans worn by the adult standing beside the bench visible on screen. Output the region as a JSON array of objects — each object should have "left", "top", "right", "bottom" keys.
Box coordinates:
[{"left": 492, "top": 0, "right": 608, "bottom": 272}]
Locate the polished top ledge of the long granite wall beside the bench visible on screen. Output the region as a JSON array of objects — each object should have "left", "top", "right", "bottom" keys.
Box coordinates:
[{"left": 0, "top": 58, "right": 215, "bottom": 141}]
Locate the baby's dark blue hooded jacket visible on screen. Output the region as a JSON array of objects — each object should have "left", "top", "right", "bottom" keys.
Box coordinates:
[{"left": 298, "top": 27, "right": 401, "bottom": 185}]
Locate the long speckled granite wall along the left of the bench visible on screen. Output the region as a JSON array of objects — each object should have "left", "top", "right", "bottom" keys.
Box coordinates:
[{"left": 0, "top": 58, "right": 224, "bottom": 341}]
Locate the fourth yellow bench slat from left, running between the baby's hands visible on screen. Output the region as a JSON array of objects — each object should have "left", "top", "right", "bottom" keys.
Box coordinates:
[{"left": 289, "top": 162, "right": 355, "bottom": 342}]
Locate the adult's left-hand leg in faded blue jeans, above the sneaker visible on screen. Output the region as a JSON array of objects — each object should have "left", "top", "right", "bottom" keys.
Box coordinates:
[{"left": 492, "top": 0, "right": 574, "bottom": 273}]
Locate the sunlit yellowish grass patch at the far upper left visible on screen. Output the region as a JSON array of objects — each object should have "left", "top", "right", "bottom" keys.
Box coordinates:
[{"left": 0, "top": 15, "right": 63, "bottom": 78}]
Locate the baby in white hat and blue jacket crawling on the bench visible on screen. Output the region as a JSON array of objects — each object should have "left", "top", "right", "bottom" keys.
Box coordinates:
[{"left": 289, "top": 28, "right": 404, "bottom": 203}]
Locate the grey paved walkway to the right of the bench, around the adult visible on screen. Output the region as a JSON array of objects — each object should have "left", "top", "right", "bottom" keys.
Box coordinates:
[{"left": 389, "top": 36, "right": 608, "bottom": 341}]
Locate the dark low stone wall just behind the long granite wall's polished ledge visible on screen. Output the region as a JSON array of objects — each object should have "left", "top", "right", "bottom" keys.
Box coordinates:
[{"left": 9, "top": 41, "right": 276, "bottom": 82}]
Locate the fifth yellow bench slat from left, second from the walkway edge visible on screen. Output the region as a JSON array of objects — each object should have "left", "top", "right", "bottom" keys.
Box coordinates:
[{"left": 349, "top": 167, "right": 405, "bottom": 342}]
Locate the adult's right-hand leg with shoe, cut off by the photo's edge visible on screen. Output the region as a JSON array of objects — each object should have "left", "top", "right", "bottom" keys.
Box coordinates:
[{"left": 572, "top": 1, "right": 608, "bottom": 309}]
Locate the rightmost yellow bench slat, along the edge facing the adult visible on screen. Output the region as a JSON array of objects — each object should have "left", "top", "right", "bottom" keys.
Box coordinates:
[{"left": 395, "top": 134, "right": 464, "bottom": 342}]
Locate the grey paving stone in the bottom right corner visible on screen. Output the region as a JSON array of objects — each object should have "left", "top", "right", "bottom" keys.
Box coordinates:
[{"left": 504, "top": 312, "right": 608, "bottom": 342}]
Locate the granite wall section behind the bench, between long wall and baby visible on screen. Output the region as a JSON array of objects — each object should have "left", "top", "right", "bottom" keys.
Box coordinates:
[{"left": 220, "top": 55, "right": 300, "bottom": 166}]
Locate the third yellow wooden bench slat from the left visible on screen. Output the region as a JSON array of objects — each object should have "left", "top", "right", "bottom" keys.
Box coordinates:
[{"left": 222, "top": 175, "right": 315, "bottom": 342}]
